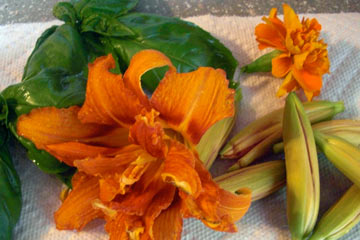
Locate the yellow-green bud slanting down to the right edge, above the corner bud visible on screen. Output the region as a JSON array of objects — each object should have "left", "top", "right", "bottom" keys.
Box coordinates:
[{"left": 314, "top": 131, "right": 360, "bottom": 187}]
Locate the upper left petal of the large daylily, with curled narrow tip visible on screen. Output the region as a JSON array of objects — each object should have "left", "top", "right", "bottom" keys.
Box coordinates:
[{"left": 79, "top": 54, "right": 144, "bottom": 126}]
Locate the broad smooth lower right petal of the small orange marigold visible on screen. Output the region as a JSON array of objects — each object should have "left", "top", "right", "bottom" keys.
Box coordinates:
[{"left": 292, "top": 69, "right": 322, "bottom": 92}]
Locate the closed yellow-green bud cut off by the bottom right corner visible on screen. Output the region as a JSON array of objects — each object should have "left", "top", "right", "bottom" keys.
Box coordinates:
[{"left": 309, "top": 184, "right": 360, "bottom": 240}]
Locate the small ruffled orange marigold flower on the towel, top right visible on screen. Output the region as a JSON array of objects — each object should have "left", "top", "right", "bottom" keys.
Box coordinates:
[{"left": 255, "top": 4, "right": 330, "bottom": 101}]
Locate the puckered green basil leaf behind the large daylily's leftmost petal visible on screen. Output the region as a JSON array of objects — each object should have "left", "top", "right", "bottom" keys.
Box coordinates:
[{"left": 2, "top": 24, "right": 89, "bottom": 183}]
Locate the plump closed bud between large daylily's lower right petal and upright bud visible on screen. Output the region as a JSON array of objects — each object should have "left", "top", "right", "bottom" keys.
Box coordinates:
[{"left": 214, "top": 160, "right": 286, "bottom": 201}]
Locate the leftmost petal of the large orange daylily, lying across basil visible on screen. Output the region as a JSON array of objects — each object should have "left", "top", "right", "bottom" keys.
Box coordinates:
[{"left": 17, "top": 106, "right": 109, "bottom": 149}]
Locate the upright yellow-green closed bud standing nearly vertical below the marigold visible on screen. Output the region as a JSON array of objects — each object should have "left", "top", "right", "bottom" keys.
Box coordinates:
[{"left": 283, "top": 93, "right": 320, "bottom": 239}]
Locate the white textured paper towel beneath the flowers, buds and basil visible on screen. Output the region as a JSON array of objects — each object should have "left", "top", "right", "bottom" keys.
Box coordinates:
[{"left": 0, "top": 13, "right": 360, "bottom": 240}]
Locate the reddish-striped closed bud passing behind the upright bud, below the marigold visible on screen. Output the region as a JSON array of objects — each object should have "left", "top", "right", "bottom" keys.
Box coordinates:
[{"left": 224, "top": 101, "right": 344, "bottom": 170}]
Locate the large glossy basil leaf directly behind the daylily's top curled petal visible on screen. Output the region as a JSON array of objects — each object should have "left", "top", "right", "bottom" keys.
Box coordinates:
[{"left": 94, "top": 13, "right": 238, "bottom": 91}]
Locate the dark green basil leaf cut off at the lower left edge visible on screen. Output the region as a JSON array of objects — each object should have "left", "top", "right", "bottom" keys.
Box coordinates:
[{"left": 0, "top": 126, "right": 21, "bottom": 240}]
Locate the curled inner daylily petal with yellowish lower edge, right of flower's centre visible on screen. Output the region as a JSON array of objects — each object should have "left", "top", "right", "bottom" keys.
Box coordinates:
[{"left": 161, "top": 141, "right": 201, "bottom": 198}]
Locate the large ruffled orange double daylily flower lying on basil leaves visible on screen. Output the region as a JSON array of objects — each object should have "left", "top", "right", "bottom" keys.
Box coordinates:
[{"left": 17, "top": 50, "right": 251, "bottom": 240}]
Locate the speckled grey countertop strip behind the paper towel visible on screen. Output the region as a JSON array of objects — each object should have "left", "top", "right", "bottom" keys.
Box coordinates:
[{"left": 0, "top": 0, "right": 360, "bottom": 25}]
